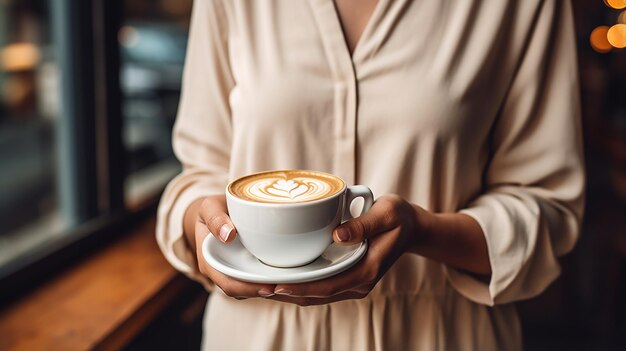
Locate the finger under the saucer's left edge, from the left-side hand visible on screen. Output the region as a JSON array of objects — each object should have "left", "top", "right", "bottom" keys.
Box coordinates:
[{"left": 198, "top": 246, "right": 276, "bottom": 298}]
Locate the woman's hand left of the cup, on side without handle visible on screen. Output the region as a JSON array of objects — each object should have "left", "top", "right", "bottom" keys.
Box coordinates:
[{"left": 184, "top": 195, "right": 276, "bottom": 299}]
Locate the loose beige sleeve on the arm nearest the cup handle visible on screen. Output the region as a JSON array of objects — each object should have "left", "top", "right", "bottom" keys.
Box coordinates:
[{"left": 447, "top": 1, "right": 584, "bottom": 305}]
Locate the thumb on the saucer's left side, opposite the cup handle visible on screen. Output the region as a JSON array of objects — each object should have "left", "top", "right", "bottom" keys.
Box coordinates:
[{"left": 199, "top": 196, "right": 237, "bottom": 243}]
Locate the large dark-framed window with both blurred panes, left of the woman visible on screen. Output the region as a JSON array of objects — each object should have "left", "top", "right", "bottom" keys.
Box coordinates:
[{"left": 0, "top": 0, "right": 192, "bottom": 295}]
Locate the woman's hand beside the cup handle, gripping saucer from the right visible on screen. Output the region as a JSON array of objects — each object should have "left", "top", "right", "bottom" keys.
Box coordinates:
[{"left": 268, "top": 195, "right": 431, "bottom": 306}]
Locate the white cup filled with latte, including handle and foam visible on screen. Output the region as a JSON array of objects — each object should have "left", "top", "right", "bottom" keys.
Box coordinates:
[{"left": 226, "top": 170, "right": 374, "bottom": 267}]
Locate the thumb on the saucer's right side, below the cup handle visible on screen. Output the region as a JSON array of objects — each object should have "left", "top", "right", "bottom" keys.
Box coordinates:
[{"left": 333, "top": 196, "right": 398, "bottom": 245}]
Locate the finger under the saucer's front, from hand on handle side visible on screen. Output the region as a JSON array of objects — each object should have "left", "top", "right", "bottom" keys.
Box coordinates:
[{"left": 274, "top": 254, "right": 377, "bottom": 298}]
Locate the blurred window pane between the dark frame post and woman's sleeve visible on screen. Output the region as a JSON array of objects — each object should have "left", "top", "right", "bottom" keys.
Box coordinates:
[{"left": 118, "top": 0, "right": 192, "bottom": 208}]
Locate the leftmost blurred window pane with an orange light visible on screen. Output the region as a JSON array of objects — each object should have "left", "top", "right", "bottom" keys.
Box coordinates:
[{"left": 0, "top": 0, "right": 71, "bottom": 274}]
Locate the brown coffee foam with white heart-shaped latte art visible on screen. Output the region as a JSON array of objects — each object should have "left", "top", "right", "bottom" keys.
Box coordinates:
[{"left": 228, "top": 170, "right": 345, "bottom": 203}]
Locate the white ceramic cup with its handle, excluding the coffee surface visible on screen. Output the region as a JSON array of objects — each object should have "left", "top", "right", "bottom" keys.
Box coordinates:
[{"left": 226, "top": 173, "right": 374, "bottom": 267}]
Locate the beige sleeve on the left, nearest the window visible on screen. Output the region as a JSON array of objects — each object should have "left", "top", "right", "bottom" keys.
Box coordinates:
[{"left": 156, "top": 0, "right": 234, "bottom": 288}]
